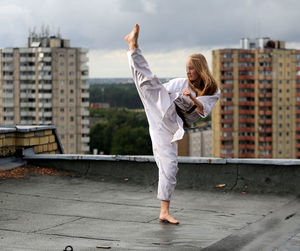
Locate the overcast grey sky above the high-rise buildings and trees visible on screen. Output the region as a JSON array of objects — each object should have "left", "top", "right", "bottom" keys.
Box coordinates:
[{"left": 0, "top": 0, "right": 300, "bottom": 77}]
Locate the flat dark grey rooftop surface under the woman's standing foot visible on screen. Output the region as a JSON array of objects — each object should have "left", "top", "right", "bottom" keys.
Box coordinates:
[{"left": 0, "top": 168, "right": 300, "bottom": 251}]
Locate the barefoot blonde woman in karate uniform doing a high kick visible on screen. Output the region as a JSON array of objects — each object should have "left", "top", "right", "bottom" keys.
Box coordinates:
[{"left": 125, "top": 24, "right": 220, "bottom": 224}]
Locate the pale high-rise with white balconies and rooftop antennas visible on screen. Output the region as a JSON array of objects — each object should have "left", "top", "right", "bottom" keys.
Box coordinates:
[{"left": 0, "top": 32, "right": 89, "bottom": 153}]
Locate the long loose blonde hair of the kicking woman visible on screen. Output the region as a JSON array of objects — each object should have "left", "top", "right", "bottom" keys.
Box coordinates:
[{"left": 188, "top": 53, "right": 218, "bottom": 97}]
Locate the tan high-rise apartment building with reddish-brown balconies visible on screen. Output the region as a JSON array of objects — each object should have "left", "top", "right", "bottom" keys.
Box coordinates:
[{"left": 212, "top": 38, "right": 300, "bottom": 158}]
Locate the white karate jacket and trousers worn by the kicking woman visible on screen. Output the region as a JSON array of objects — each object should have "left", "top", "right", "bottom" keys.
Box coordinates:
[{"left": 128, "top": 48, "right": 220, "bottom": 201}]
